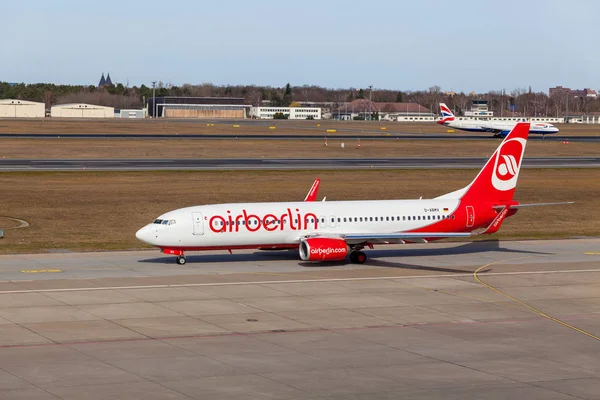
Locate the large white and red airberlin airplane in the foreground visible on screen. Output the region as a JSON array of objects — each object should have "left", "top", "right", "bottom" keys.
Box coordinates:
[{"left": 136, "top": 123, "right": 565, "bottom": 265}]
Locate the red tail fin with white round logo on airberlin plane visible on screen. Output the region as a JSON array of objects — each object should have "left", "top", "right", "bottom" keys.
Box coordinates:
[{"left": 462, "top": 122, "right": 529, "bottom": 202}]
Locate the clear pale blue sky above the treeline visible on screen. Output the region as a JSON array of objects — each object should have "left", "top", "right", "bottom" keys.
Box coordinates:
[{"left": 0, "top": 0, "right": 600, "bottom": 92}]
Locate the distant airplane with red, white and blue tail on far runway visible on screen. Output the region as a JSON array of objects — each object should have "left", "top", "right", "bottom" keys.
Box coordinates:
[{"left": 437, "top": 103, "right": 558, "bottom": 137}]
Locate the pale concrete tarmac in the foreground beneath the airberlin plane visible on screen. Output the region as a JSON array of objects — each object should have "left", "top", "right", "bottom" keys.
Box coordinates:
[{"left": 0, "top": 238, "right": 600, "bottom": 400}]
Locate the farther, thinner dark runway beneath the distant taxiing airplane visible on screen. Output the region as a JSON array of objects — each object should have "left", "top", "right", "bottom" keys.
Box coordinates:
[{"left": 0, "top": 128, "right": 600, "bottom": 143}]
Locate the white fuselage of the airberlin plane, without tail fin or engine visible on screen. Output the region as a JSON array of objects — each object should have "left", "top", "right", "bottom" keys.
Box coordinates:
[{"left": 137, "top": 199, "right": 504, "bottom": 250}]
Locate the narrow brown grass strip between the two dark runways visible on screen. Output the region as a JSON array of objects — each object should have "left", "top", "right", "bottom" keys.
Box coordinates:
[{"left": 0, "top": 138, "right": 600, "bottom": 158}]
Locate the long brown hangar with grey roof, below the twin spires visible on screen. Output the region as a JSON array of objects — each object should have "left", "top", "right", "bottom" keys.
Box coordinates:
[{"left": 148, "top": 96, "right": 251, "bottom": 119}]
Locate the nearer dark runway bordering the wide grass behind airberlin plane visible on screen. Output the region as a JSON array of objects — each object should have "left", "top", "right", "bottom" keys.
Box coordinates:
[{"left": 0, "top": 157, "right": 600, "bottom": 171}]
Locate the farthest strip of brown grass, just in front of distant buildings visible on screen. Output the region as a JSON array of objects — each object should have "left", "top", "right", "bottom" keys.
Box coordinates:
[{"left": 0, "top": 118, "right": 600, "bottom": 136}]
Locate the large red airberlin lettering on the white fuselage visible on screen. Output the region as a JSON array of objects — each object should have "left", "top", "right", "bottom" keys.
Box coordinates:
[{"left": 208, "top": 208, "right": 319, "bottom": 233}]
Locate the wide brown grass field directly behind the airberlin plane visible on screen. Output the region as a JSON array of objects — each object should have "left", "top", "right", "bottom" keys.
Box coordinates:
[{"left": 0, "top": 169, "right": 600, "bottom": 253}]
